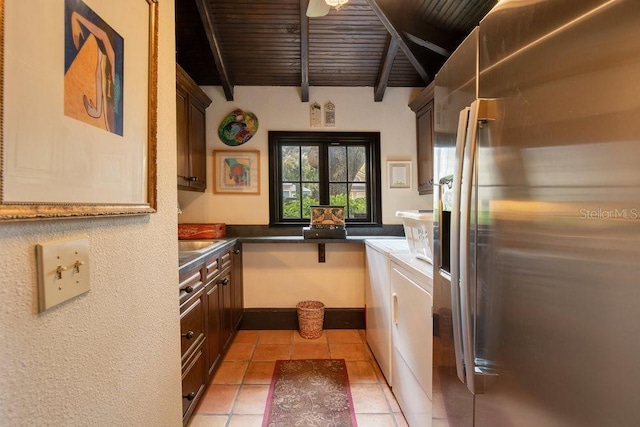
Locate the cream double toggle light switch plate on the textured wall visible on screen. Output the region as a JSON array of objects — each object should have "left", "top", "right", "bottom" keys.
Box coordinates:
[{"left": 36, "top": 237, "right": 90, "bottom": 313}]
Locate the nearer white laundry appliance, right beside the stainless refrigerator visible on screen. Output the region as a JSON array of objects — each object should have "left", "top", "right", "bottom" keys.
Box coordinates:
[{"left": 391, "top": 253, "right": 433, "bottom": 427}]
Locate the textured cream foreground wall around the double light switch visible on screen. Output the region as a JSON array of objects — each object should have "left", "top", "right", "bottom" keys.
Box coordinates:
[{"left": 0, "top": 0, "right": 182, "bottom": 427}]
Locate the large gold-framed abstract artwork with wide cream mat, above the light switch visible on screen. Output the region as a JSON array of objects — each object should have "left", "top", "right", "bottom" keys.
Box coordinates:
[{"left": 0, "top": 0, "right": 158, "bottom": 221}]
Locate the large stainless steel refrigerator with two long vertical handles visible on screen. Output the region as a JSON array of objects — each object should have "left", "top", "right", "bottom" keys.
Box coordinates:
[{"left": 433, "top": 0, "right": 640, "bottom": 427}]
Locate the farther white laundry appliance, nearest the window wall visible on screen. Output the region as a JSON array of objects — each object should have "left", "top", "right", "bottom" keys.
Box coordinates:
[{"left": 365, "top": 238, "right": 409, "bottom": 386}]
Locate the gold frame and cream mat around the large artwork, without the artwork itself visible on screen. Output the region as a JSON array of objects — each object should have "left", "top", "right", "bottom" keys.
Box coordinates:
[{"left": 0, "top": 0, "right": 159, "bottom": 221}]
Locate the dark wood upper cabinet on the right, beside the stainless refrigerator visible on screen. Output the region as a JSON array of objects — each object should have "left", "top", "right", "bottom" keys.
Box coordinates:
[{"left": 409, "top": 82, "right": 434, "bottom": 195}]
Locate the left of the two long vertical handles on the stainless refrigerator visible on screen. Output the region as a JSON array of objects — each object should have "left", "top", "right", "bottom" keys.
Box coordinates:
[{"left": 450, "top": 107, "right": 470, "bottom": 383}]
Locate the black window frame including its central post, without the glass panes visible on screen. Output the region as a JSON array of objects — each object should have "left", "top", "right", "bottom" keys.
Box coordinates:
[{"left": 269, "top": 131, "right": 382, "bottom": 227}]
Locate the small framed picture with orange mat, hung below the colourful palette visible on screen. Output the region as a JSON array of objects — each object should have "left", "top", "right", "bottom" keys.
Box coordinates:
[{"left": 213, "top": 150, "right": 260, "bottom": 194}]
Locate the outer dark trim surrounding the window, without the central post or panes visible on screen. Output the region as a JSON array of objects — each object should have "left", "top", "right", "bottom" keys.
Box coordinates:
[{"left": 269, "top": 131, "right": 382, "bottom": 227}]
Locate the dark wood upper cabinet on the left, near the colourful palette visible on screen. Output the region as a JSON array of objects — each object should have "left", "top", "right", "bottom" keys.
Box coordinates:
[{"left": 176, "top": 65, "right": 211, "bottom": 191}]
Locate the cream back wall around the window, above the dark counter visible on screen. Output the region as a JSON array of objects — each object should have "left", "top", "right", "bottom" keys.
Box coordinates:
[{"left": 178, "top": 86, "right": 432, "bottom": 225}]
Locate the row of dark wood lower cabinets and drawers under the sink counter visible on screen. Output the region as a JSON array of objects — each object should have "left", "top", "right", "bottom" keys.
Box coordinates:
[{"left": 180, "top": 244, "right": 243, "bottom": 425}]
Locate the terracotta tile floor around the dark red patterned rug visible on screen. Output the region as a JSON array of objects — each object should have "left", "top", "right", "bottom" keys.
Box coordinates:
[{"left": 188, "top": 329, "right": 407, "bottom": 427}]
